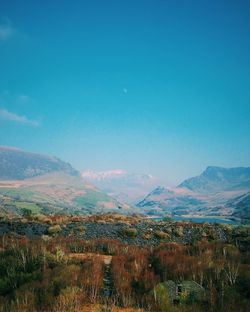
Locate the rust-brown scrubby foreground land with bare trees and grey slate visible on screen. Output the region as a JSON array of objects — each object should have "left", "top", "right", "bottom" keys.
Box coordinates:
[{"left": 0, "top": 214, "right": 250, "bottom": 312}]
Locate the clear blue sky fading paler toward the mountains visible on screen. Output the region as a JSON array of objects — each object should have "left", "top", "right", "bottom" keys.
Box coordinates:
[{"left": 0, "top": 0, "right": 250, "bottom": 185}]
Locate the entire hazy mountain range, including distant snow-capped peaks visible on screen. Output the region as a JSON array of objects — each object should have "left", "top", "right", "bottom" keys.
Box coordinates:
[{"left": 0, "top": 146, "right": 250, "bottom": 220}]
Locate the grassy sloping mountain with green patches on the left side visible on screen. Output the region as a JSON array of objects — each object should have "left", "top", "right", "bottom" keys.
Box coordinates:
[{"left": 0, "top": 146, "right": 129, "bottom": 214}]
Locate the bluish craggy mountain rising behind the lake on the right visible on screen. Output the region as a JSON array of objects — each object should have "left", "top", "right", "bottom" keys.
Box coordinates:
[{"left": 137, "top": 166, "right": 250, "bottom": 219}]
